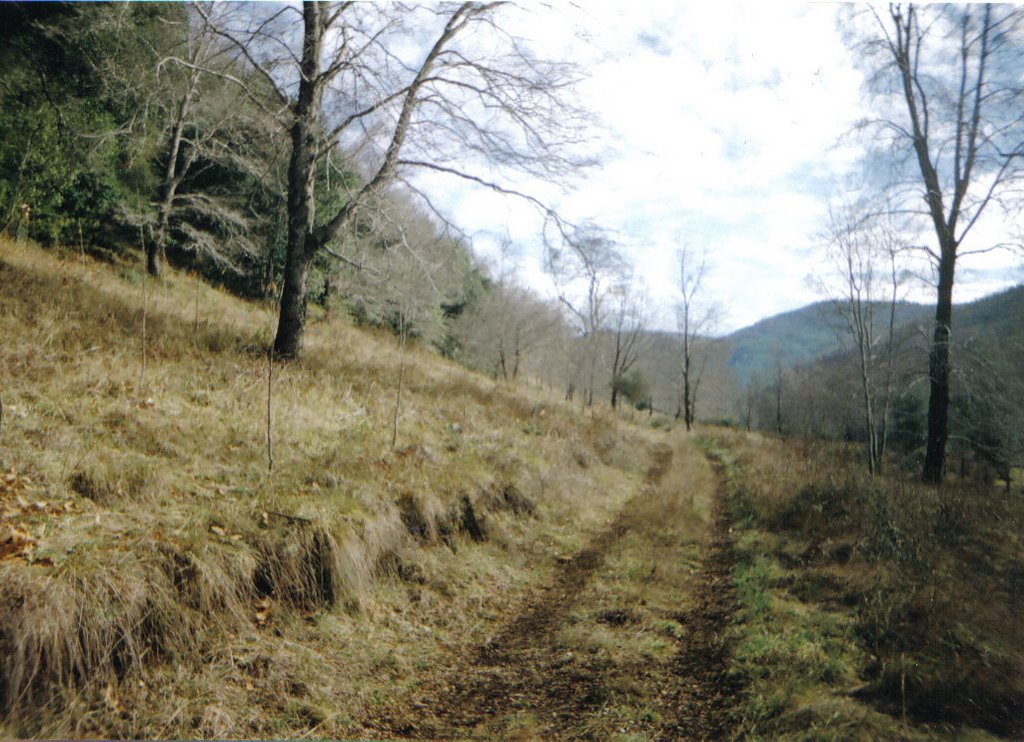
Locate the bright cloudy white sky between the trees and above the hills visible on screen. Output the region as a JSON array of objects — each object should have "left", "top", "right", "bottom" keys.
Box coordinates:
[{"left": 411, "top": 0, "right": 1024, "bottom": 334}]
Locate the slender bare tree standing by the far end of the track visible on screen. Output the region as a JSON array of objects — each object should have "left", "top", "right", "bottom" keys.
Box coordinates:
[{"left": 676, "top": 247, "right": 715, "bottom": 430}]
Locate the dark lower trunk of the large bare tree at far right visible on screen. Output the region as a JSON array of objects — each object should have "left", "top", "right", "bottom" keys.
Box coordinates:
[{"left": 921, "top": 241, "right": 956, "bottom": 484}]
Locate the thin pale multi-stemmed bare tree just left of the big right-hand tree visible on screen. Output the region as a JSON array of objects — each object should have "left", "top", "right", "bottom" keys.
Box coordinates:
[{"left": 818, "top": 207, "right": 907, "bottom": 476}]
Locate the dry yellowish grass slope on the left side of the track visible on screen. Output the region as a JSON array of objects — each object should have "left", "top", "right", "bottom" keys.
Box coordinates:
[{"left": 0, "top": 241, "right": 647, "bottom": 737}]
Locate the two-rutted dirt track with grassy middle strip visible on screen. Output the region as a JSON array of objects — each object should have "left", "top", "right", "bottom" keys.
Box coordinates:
[{"left": 368, "top": 437, "right": 737, "bottom": 739}]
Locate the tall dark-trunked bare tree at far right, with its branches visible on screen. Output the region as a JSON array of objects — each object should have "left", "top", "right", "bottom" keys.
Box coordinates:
[{"left": 851, "top": 4, "right": 1024, "bottom": 483}]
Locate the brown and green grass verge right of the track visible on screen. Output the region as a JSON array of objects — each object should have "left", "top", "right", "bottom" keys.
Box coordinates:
[{"left": 712, "top": 431, "right": 1024, "bottom": 738}]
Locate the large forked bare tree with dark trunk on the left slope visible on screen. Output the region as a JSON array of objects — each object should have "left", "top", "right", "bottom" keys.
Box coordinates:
[{"left": 192, "top": 2, "right": 580, "bottom": 357}]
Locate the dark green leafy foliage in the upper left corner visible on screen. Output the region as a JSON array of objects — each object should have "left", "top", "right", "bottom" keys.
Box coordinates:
[{"left": 0, "top": 5, "right": 157, "bottom": 245}]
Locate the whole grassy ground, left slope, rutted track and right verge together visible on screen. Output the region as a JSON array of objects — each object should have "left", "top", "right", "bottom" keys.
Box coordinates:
[{"left": 0, "top": 235, "right": 1024, "bottom": 739}]
